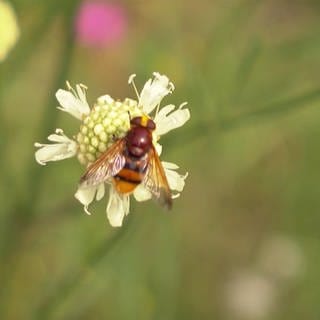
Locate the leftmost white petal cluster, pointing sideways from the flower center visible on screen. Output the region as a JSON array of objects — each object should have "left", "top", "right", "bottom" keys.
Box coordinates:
[{"left": 35, "top": 130, "right": 77, "bottom": 165}]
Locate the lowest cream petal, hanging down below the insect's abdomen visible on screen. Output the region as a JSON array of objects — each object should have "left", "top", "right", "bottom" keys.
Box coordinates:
[{"left": 107, "top": 185, "right": 130, "bottom": 227}]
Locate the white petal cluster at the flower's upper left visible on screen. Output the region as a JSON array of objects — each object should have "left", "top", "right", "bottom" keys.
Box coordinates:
[{"left": 56, "top": 85, "right": 90, "bottom": 120}]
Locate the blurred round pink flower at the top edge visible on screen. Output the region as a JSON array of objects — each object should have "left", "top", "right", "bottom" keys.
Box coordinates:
[{"left": 75, "top": 0, "right": 127, "bottom": 47}]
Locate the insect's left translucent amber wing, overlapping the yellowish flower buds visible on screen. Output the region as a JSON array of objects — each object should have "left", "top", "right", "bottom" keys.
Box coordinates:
[{"left": 80, "top": 139, "right": 126, "bottom": 186}]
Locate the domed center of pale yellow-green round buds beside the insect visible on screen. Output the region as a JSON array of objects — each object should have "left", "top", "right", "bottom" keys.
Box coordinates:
[{"left": 76, "top": 96, "right": 142, "bottom": 165}]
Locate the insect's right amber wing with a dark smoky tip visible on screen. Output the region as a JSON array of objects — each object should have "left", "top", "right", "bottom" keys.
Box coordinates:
[{"left": 143, "top": 147, "right": 172, "bottom": 209}]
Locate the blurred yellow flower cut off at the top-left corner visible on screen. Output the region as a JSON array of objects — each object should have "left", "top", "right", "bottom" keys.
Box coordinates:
[{"left": 0, "top": 0, "right": 20, "bottom": 62}]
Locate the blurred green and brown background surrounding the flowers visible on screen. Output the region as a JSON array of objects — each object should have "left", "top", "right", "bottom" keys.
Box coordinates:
[{"left": 0, "top": 0, "right": 320, "bottom": 320}]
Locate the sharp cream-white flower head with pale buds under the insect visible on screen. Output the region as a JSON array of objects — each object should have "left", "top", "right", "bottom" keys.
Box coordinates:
[{"left": 35, "top": 72, "right": 190, "bottom": 227}]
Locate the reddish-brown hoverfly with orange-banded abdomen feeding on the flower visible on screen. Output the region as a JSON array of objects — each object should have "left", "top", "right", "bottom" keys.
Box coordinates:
[{"left": 80, "top": 116, "right": 172, "bottom": 209}]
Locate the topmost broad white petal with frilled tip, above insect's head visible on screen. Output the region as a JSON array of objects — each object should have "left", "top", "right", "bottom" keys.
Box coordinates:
[{"left": 138, "top": 72, "right": 174, "bottom": 114}]
